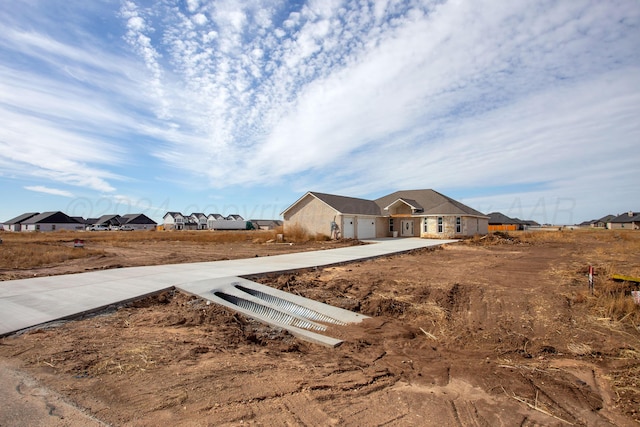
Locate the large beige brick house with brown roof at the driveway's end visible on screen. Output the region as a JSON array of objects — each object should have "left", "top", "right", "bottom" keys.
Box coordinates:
[{"left": 282, "top": 190, "right": 489, "bottom": 240}]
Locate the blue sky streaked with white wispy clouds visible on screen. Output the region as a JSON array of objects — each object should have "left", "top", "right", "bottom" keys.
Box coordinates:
[{"left": 0, "top": 0, "right": 640, "bottom": 223}]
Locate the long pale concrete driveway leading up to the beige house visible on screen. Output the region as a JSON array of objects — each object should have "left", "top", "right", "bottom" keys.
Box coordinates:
[{"left": 0, "top": 238, "right": 455, "bottom": 336}]
